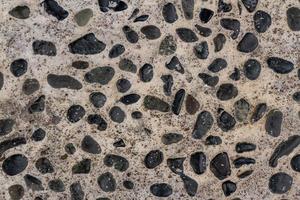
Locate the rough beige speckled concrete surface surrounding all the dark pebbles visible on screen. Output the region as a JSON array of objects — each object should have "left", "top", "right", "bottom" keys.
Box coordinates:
[{"left": 0, "top": 0, "right": 300, "bottom": 200}]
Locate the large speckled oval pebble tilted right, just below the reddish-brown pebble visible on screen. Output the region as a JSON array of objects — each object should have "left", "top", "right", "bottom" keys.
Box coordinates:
[{"left": 192, "top": 111, "right": 214, "bottom": 139}]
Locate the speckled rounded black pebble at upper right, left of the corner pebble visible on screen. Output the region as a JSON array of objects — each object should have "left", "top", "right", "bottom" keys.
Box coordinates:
[{"left": 253, "top": 10, "right": 272, "bottom": 33}]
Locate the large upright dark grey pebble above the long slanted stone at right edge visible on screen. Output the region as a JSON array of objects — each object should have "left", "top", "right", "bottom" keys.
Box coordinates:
[{"left": 265, "top": 109, "right": 283, "bottom": 137}]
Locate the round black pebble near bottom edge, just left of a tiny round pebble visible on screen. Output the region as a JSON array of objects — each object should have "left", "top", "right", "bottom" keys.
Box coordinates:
[{"left": 97, "top": 172, "right": 117, "bottom": 192}]
